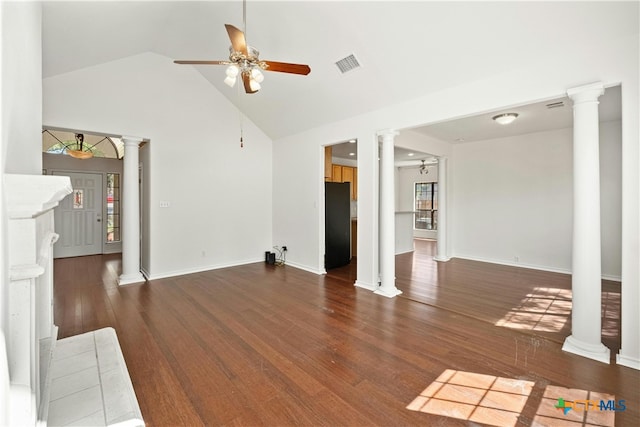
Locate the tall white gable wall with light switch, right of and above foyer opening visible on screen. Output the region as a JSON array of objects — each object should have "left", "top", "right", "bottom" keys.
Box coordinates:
[{"left": 43, "top": 53, "right": 272, "bottom": 278}]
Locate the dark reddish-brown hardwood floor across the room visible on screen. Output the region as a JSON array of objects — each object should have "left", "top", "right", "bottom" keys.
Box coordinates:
[{"left": 54, "top": 241, "right": 640, "bottom": 426}]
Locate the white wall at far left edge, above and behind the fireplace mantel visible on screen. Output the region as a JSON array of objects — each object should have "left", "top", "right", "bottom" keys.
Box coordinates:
[{"left": 0, "top": 1, "right": 42, "bottom": 425}]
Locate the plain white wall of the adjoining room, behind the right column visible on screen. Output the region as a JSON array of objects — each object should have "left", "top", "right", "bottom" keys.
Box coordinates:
[{"left": 450, "top": 121, "right": 622, "bottom": 280}]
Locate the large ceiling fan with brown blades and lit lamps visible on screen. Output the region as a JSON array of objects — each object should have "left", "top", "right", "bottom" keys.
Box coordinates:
[{"left": 173, "top": 0, "right": 311, "bottom": 93}]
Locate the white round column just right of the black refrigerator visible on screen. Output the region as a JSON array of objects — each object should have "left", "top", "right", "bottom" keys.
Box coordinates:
[{"left": 374, "top": 129, "right": 402, "bottom": 298}]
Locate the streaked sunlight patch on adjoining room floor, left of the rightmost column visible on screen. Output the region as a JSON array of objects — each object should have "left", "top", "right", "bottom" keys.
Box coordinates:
[{"left": 495, "top": 288, "right": 571, "bottom": 332}]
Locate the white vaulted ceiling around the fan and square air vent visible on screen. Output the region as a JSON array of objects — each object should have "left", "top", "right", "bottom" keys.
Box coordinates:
[{"left": 42, "top": 0, "right": 638, "bottom": 139}]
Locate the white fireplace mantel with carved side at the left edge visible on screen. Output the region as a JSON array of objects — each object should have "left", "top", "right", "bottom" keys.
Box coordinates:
[{"left": 0, "top": 174, "right": 73, "bottom": 425}]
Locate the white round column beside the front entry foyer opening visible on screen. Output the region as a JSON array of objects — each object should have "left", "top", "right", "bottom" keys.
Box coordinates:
[{"left": 119, "top": 136, "right": 144, "bottom": 285}]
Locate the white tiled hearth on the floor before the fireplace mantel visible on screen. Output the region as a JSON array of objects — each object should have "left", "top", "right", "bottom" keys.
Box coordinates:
[{"left": 47, "top": 328, "right": 144, "bottom": 426}]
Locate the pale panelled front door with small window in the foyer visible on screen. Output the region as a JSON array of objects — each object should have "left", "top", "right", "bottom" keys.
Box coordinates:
[{"left": 53, "top": 172, "right": 103, "bottom": 258}]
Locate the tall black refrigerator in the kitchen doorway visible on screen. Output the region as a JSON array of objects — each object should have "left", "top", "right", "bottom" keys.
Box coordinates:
[{"left": 324, "top": 182, "right": 351, "bottom": 270}]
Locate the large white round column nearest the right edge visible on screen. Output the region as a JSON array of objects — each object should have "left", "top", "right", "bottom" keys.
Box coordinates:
[{"left": 562, "top": 83, "right": 610, "bottom": 363}]
